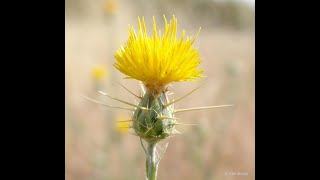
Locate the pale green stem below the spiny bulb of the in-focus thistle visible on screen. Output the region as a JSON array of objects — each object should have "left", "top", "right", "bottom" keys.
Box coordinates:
[{"left": 146, "top": 143, "right": 158, "bottom": 180}]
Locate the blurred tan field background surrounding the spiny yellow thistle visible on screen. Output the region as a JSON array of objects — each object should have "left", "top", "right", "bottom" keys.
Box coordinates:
[{"left": 65, "top": 0, "right": 255, "bottom": 180}]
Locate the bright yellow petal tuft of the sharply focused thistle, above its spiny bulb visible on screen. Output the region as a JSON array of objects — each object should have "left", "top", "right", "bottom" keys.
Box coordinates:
[{"left": 114, "top": 16, "right": 203, "bottom": 95}]
